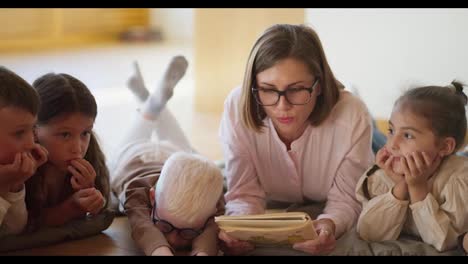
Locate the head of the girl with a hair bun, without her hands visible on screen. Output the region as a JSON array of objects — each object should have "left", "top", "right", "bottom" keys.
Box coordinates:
[{"left": 387, "top": 82, "right": 467, "bottom": 173}]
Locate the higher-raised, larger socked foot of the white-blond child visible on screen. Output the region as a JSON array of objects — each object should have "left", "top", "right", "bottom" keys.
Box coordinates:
[{"left": 143, "top": 56, "right": 188, "bottom": 118}]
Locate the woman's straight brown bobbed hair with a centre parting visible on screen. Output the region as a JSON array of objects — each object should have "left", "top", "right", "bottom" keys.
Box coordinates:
[{"left": 240, "top": 24, "right": 344, "bottom": 132}]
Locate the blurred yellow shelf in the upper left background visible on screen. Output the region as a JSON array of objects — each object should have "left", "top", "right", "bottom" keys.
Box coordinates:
[{"left": 0, "top": 8, "right": 149, "bottom": 52}]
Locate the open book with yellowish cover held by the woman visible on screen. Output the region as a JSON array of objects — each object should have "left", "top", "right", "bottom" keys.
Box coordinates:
[{"left": 215, "top": 212, "right": 317, "bottom": 245}]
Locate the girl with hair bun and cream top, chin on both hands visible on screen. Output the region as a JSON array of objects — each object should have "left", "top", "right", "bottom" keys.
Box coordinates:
[{"left": 356, "top": 81, "right": 468, "bottom": 251}]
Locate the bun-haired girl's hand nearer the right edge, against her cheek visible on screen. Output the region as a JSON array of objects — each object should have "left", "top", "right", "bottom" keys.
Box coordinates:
[{"left": 403, "top": 152, "right": 442, "bottom": 187}]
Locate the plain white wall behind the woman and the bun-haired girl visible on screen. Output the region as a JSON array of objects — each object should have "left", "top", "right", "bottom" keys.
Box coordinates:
[{"left": 306, "top": 9, "right": 468, "bottom": 118}]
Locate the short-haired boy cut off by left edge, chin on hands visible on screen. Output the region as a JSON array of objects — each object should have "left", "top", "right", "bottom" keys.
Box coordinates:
[{"left": 0, "top": 67, "right": 47, "bottom": 237}]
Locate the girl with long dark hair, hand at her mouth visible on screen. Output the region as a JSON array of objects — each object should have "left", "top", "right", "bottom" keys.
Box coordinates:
[{"left": 26, "top": 73, "right": 109, "bottom": 231}]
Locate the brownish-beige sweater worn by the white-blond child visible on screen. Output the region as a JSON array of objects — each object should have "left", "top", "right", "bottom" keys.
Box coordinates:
[{"left": 111, "top": 141, "right": 224, "bottom": 255}]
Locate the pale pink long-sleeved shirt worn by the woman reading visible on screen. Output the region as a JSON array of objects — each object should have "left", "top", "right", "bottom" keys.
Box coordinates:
[{"left": 219, "top": 88, "right": 374, "bottom": 237}]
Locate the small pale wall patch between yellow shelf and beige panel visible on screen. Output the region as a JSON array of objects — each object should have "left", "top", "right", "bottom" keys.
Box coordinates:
[{"left": 150, "top": 8, "right": 194, "bottom": 41}]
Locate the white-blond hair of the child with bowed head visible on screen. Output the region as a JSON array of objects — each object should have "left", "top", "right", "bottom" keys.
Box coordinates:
[{"left": 155, "top": 152, "right": 223, "bottom": 225}]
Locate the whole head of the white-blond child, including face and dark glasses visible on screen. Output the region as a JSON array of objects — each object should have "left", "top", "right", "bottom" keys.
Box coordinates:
[{"left": 153, "top": 152, "right": 223, "bottom": 248}]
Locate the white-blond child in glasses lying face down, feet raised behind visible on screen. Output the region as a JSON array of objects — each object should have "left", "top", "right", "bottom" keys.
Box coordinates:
[{"left": 111, "top": 56, "right": 224, "bottom": 256}]
